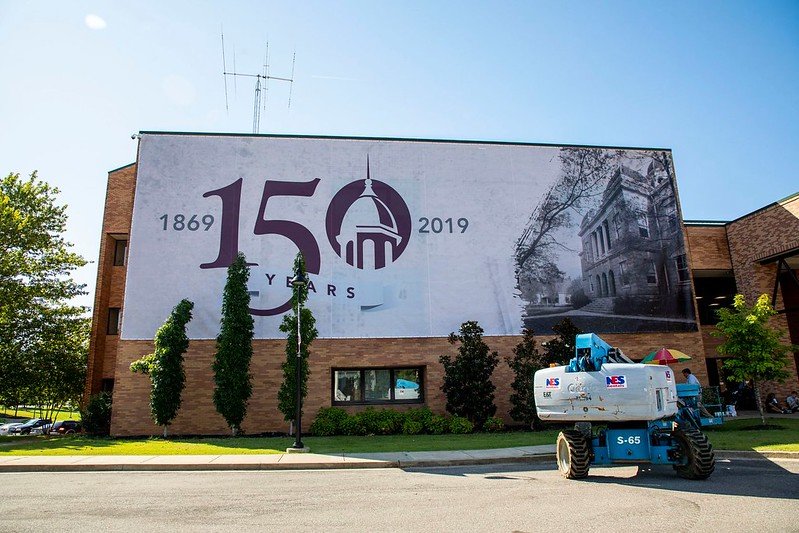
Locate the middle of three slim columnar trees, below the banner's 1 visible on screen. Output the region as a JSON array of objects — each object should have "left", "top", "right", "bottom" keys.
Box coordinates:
[{"left": 212, "top": 252, "right": 254, "bottom": 436}]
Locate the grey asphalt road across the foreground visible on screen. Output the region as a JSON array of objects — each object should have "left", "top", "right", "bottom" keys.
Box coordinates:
[{"left": 0, "top": 459, "right": 799, "bottom": 533}]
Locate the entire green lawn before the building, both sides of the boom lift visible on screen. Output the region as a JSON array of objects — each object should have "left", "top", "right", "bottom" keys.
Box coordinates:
[{"left": 0, "top": 417, "right": 799, "bottom": 456}]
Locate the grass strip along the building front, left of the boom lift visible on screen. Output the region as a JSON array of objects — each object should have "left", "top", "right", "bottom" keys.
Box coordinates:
[{"left": 0, "top": 430, "right": 557, "bottom": 456}]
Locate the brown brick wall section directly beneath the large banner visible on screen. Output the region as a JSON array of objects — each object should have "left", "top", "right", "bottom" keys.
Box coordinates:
[{"left": 111, "top": 333, "right": 707, "bottom": 436}]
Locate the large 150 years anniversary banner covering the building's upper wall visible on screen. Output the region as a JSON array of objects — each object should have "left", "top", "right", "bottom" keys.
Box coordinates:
[{"left": 122, "top": 133, "right": 696, "bottom": 339}]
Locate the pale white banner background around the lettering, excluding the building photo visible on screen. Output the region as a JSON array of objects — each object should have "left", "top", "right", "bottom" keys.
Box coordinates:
[{"left": 122, "top": 134, "right": 588, "bottom": 339}]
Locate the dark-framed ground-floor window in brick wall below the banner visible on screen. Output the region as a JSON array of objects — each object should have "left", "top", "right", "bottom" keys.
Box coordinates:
[{"left": 333, "top": 367, "right": 424, "bottom": 405}]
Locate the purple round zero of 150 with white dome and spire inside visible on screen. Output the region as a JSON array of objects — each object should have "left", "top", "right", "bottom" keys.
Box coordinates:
[{"left": 325, "top": 158, "right": 411, "bottom": 270}]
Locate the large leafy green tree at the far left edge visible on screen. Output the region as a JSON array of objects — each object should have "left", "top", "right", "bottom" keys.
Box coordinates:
[{"left": 0, "top": 172, "right": 88, "bottom": 412}]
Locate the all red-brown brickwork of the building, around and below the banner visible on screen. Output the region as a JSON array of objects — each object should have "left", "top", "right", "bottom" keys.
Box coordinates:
[{"left": 86, "top": 165, "right": 799, "bottom": 435}]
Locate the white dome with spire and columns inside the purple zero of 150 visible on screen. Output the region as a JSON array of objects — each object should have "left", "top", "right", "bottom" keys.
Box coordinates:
[{"left": 336, "top": 158, "right": 402, "bottom": 270}]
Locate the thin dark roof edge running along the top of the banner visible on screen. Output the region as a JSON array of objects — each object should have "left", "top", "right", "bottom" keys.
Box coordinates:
[{"left": 139, "top": 131, "right": 671, "bottom": 153}]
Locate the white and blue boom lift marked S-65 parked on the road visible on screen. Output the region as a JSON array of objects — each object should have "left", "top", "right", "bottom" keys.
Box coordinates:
[{"left": 534, "top": 333, "right": 715, "bottom": 479}]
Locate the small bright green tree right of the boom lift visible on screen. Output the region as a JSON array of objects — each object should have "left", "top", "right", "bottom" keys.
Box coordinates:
[{"left": 711, "top": 294, "right": 799, "bottom": 425}]
